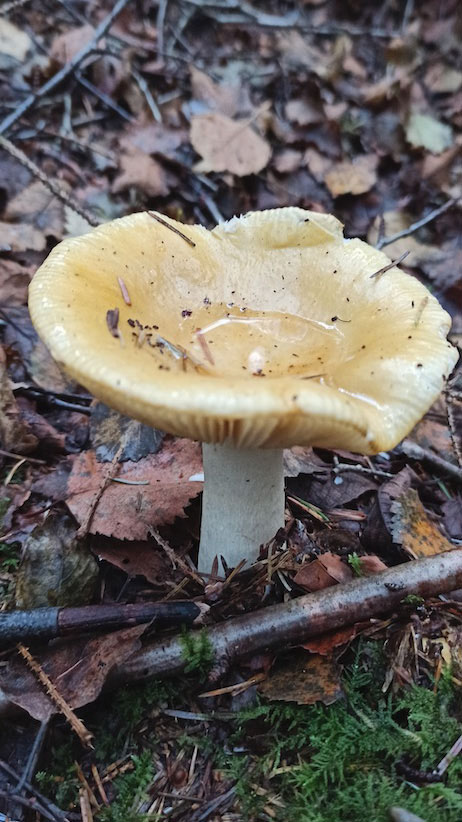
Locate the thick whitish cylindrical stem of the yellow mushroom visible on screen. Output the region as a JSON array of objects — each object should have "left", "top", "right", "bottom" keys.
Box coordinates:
[{"left": 198, "top": 443, "right": 284, "bottom": 572}]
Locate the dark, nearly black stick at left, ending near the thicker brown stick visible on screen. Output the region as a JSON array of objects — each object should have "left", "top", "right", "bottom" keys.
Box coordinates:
[{"left": 0, "top": 601, "right": 208, "bottom": 648}]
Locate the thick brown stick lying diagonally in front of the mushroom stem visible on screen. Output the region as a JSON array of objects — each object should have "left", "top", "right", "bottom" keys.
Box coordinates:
[{"left": 0, "top": 548, "right": 462, "bottom": 715}]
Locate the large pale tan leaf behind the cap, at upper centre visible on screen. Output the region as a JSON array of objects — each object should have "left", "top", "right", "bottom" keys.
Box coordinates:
[{"left": 190, "top": 114, "right": 271, "bottom": 177}]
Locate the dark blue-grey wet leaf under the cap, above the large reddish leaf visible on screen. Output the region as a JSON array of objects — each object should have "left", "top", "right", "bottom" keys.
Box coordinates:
[{"left": 90, "top": 401, "right": 165, "bottom": 462}]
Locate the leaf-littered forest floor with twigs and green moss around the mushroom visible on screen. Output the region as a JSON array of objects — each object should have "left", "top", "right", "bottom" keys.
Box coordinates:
[{"left": 0, "top": 0, "right": 462, "bottom": 822}]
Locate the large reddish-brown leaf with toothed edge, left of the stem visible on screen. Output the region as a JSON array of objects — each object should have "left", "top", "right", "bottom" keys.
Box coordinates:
[{"left": 67, "top": 439, "right": 202, "bottom": 541}]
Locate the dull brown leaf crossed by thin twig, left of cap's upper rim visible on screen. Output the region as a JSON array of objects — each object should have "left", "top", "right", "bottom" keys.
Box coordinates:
[{"left": 4, "top": 180, "right": 64, "bottom": 240}]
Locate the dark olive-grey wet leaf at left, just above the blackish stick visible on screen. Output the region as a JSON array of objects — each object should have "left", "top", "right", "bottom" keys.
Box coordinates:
[{"left": 15, "top": 514, "right": 99, "bottom": 610}]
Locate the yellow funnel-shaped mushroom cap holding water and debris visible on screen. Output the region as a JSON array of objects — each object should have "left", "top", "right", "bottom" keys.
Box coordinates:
[{"left": 30, "top": 208, "right": 457, "bottom": 454}]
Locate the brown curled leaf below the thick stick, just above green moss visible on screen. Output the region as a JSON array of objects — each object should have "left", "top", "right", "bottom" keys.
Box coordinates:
[{"left": 258, "top": 651, "right": 343, "bottom": 705}]
